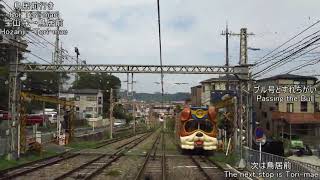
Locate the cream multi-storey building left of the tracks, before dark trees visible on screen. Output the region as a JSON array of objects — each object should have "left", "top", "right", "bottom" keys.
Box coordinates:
[{"left": 59, "top": 89, "right": 103, "bottom": 118}]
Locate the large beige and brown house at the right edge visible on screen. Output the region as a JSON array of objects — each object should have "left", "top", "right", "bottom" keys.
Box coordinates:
[{"left": 254, "top": 74, "right": 320, "bottom": 139}]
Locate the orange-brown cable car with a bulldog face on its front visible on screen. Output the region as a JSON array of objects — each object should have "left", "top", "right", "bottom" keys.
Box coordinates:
[{"left": 179, "top": 107, "right": 218, "bottom": 150}]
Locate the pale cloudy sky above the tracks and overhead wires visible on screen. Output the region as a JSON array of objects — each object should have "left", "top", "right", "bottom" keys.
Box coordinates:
[{"left": 5, "top": 0, "right": 320, "bottom": 93}]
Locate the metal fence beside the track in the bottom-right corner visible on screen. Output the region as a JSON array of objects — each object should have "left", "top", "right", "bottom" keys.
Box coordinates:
[{"left": 243, "top": 147, "right": 320, "bottom": 180}]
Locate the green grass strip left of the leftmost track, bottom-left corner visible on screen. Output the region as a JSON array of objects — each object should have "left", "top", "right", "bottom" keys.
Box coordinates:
[{"left": 0, "top": 151, "right": 58, "bottom": 170}]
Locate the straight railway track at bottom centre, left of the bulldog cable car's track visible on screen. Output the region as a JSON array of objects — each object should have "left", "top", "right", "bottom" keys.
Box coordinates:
[{"left": 135, "top": 133, "right": 167, "bottom": 180}]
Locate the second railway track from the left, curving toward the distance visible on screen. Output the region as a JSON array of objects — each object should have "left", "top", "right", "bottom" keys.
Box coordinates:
[{"left": 54, "top": 133, "right": 150, "bottom": 180}]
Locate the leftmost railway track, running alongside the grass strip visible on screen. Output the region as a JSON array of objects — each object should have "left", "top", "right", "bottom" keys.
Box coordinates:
[{"left": 0, "top": 132, "right": 152, "bottom": 180}]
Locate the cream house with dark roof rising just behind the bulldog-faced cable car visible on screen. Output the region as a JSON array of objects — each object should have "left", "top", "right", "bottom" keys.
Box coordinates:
[{"left": 200, "top": 75, "right": 238, "bottom": 106}]
